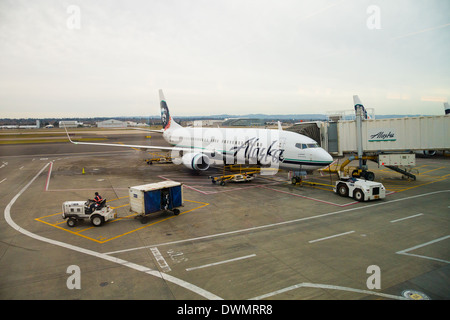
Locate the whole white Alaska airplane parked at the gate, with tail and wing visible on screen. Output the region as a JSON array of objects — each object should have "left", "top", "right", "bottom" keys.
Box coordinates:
[{"left": 66, "top": 90, "right": 333, "bottom": 176}]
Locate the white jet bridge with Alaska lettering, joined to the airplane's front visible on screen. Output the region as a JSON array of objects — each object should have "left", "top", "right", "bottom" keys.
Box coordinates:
[{"left": 287, "top": 96, "right": 450, "bottom": 179}]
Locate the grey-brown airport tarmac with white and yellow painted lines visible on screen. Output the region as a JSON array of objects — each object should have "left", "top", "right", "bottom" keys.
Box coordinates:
[{"left": 0, "top": 132, "right": 450, "bottom": 300}]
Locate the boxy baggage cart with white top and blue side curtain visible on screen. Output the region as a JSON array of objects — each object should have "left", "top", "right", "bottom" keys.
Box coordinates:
[{"left": 128, "top": 181, "right": 184, "bottom": 224}]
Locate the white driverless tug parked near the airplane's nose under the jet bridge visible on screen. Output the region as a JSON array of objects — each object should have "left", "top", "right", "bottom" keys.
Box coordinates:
[{"left": 333, "top": 177, "right": 386, "bottom": 201}]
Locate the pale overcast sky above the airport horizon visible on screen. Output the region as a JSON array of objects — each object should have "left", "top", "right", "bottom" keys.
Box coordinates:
[{"left": 0, "top": 0, "right": 450, "bottom": 118}]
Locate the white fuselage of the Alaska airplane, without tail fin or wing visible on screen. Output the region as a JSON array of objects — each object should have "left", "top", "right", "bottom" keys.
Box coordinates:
[{"left": 163, "top": 127, "right": 333, "bottom": 171}]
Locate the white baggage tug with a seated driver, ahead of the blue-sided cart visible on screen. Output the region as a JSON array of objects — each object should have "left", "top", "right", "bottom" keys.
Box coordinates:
[{"left": 62, "top": 199, "right": 116, "bottom": 228}]
